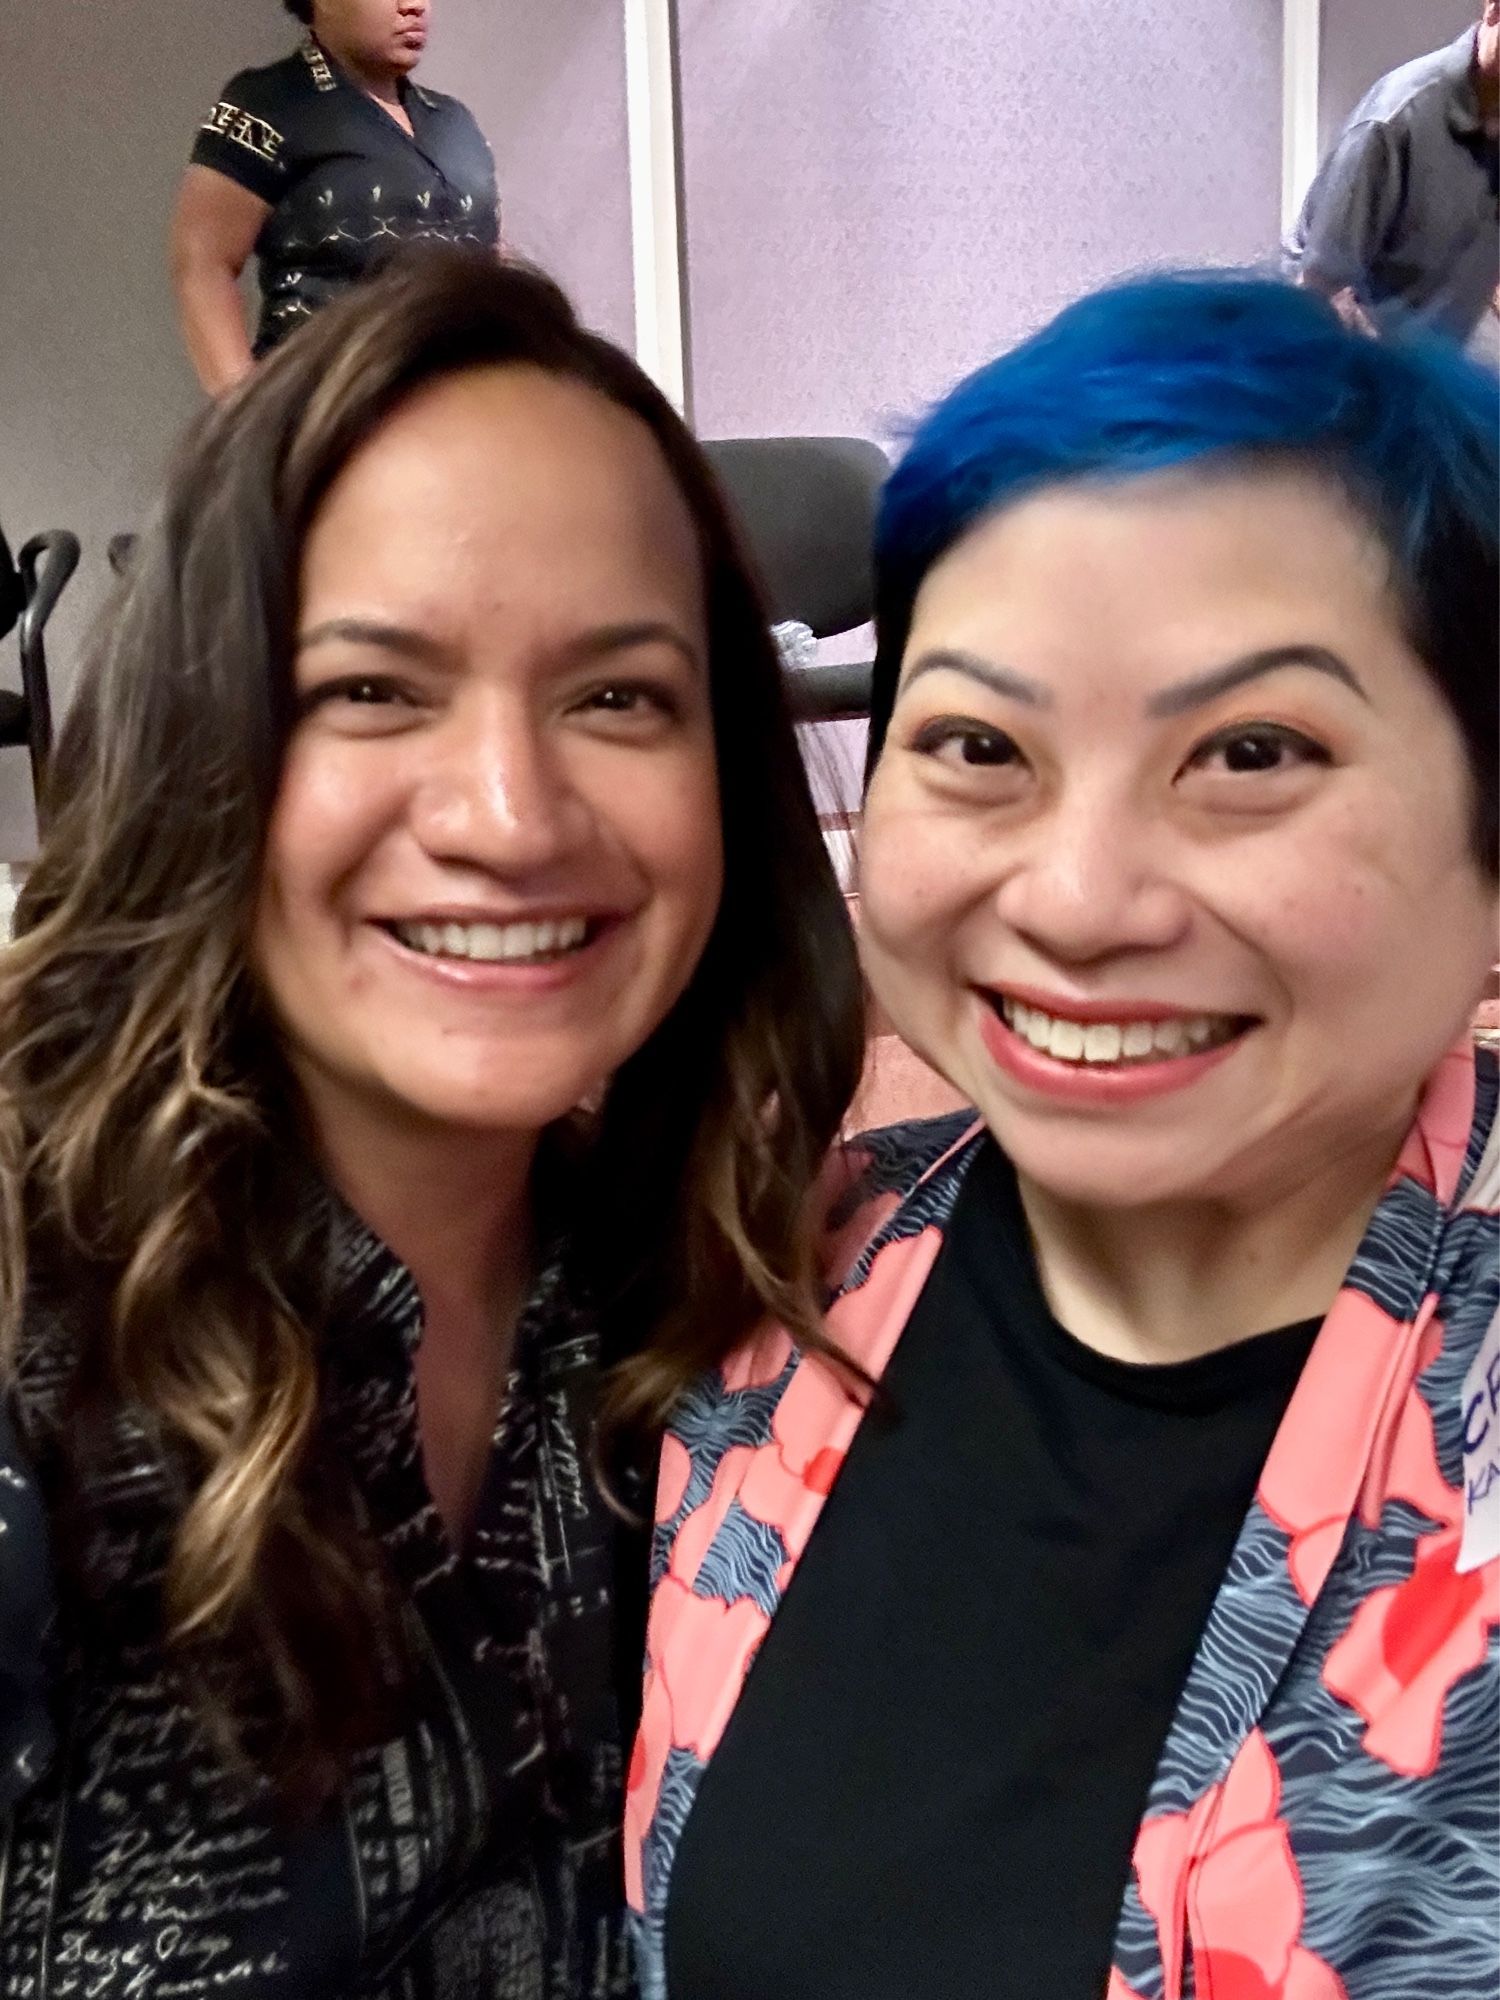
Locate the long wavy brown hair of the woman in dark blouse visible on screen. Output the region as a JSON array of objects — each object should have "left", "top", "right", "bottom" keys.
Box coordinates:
[{"left": 0, "top": 250, "right": 862, "bottom": 1794}]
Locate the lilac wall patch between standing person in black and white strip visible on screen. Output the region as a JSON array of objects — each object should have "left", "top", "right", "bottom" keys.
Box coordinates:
[{"left": 422, "top": 0, "right": 636, "bottom": 346}]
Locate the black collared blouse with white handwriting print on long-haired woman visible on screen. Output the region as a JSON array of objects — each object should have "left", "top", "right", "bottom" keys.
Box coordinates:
[{"left": 0, "top": 1184, "right": 632, "bottom": 2000}]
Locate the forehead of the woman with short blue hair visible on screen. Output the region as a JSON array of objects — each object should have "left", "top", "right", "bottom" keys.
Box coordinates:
[{"left": 912, "top": 470, "right": 1400, "bottom": 668}]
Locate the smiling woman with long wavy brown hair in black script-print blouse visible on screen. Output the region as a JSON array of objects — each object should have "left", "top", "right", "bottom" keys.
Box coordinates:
[{"left": 0, "top": 250, "right": 860, "bottom": 2000}]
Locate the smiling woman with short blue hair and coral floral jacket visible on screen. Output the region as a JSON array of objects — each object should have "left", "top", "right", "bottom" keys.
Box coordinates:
[{"left": 628, "top": 276, "right": 1500, "bottom": 2000}]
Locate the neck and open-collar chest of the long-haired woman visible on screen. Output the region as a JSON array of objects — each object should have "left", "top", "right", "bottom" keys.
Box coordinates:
[{"left": 304, "top": 1080, "right": 538, "bottom": 1326}]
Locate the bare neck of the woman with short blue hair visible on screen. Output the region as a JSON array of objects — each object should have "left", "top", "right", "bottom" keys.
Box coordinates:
[{"left": 1020, "top": 1128, "right": 1406, "bottom": 1362}]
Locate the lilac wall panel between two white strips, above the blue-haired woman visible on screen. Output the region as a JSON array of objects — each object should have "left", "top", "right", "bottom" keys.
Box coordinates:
[{"left": 682, "top": 0, "right": 1282, "bottom": 436}]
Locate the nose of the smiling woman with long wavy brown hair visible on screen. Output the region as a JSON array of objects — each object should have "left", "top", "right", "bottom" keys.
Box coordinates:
[{"left": 408, "top": 698, "right": 596, "bottom": 878}]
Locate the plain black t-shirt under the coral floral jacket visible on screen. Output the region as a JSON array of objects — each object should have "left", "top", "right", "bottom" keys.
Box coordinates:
[{"left": 666, "top": 1146, "right": 1316, "bottom": 2000}]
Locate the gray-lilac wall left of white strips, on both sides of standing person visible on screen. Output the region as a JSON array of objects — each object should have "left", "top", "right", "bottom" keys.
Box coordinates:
[{"left": 0, "top": 0, "right": 632, "bottom": 858}]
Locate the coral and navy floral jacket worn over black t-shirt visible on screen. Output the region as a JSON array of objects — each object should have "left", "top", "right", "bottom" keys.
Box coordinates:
[{"left": 626, "top": 1048, "right": 1500, "bottom": 2000}]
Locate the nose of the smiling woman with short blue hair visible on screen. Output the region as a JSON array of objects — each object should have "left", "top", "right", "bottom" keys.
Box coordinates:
[{"left": 996, "top": 794, "right": 1192, "bottom": 966}]
